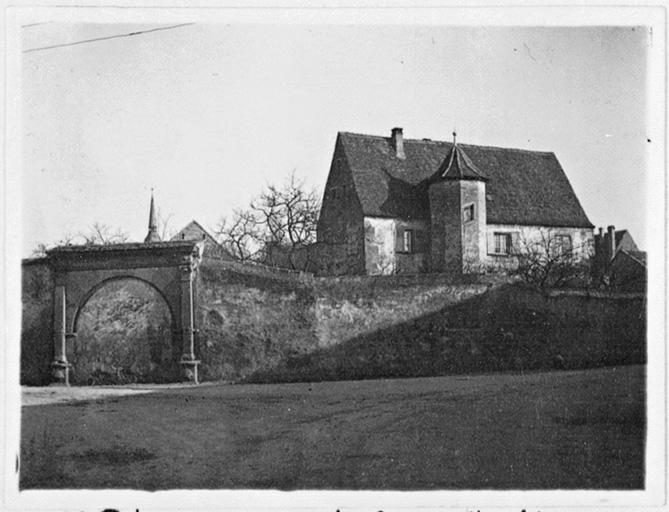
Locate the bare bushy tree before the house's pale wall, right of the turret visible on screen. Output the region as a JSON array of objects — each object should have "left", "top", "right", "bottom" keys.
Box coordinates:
[{"left": 511, "top": 230, "right": 590, "bottom": 289}]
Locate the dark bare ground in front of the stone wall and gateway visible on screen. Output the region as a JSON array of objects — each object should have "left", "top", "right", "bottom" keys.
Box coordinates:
[{"left": 20, "top": 366, "right": 645, "bottom": 490}]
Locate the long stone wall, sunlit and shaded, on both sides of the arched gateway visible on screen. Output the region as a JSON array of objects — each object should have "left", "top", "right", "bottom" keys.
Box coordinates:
[{"left": 21, "top": 258, "right": 646, "bottom": 384}]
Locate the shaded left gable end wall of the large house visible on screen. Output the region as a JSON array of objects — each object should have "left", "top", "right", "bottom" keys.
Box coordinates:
[{"left": 317, "top": 136, "right": 365, "bottom": 275}]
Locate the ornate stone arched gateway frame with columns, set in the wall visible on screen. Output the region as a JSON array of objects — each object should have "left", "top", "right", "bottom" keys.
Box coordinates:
[{"left": 47, "top": 237, "right": 203, "bottom": 385}]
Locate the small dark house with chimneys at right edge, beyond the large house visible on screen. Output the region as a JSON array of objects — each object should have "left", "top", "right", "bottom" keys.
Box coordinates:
[{"left": 593, "top": 226, "right": 648, "bottom": 292}]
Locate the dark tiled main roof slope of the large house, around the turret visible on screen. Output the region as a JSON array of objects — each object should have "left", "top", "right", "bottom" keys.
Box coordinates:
[{"left": 339, "top": 132, "right": 592, "bottom": 228}]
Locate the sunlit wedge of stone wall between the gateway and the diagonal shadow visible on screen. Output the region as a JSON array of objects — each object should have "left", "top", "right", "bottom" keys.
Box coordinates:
[{"left": 196, "top": 260, "right": 488, "bottom": 380}]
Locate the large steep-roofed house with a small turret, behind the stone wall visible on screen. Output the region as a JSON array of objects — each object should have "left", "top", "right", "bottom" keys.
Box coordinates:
[{"left": 318, "top": 128, "right": 593, "bottom": 275}]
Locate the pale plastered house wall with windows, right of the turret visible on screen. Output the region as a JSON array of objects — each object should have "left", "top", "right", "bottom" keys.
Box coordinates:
[{"left": 483, "top": 224, "right": 594, "bottom": 268}]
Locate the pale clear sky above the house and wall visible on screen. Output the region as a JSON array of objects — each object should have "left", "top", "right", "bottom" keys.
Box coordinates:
[{"left": 21, "top": 22, "right": 652, "bottom": 256}]
